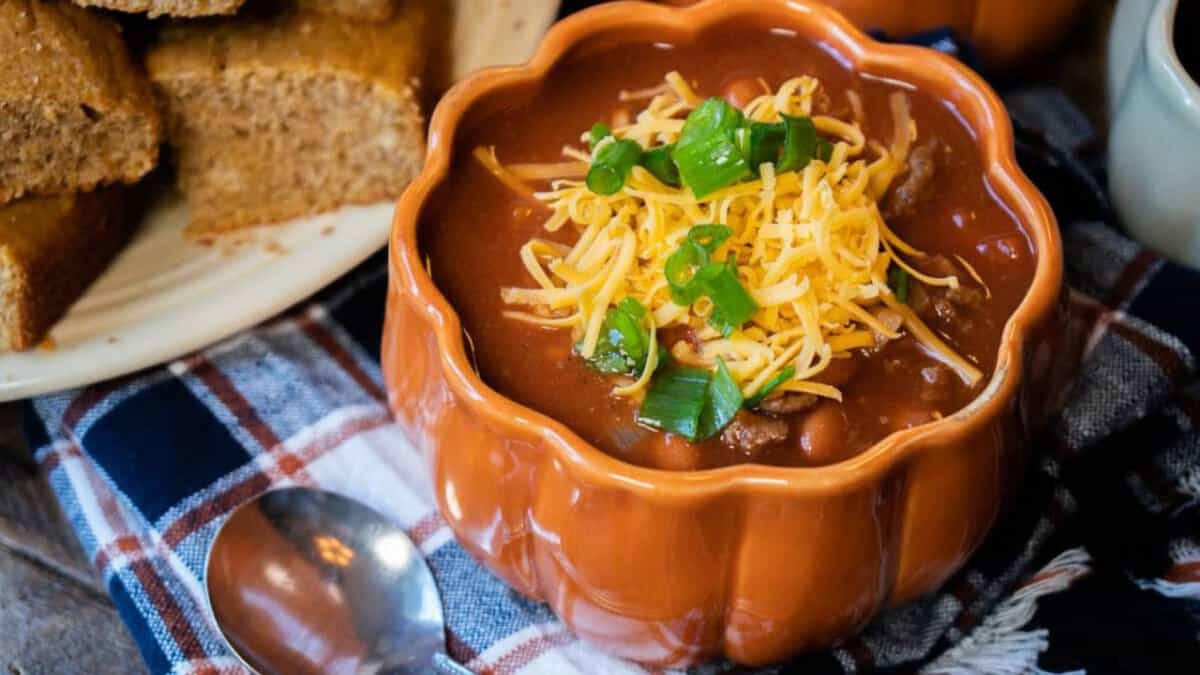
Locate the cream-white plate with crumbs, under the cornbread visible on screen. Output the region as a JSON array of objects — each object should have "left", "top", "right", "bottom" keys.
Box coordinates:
[{"left": 0, "top": 0, "right": 559, "bottom": 400}]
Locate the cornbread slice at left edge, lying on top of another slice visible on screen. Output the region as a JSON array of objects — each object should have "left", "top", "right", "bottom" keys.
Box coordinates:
[{"left": 0, "top": 0, "right": 162, "bottom": 204}]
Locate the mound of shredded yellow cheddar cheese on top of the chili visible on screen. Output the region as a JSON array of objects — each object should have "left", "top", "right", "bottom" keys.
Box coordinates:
[{"left": 475, "top": 72, "right": 983, "bottom": 400}]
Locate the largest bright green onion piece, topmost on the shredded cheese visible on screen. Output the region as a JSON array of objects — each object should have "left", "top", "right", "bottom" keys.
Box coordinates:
[{"left": 673, "top": 98, "right": 751, "bottom": 197}]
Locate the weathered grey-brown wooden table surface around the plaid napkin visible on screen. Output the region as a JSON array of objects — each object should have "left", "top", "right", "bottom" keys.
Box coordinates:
[{"left": 0, "top": 0, "right": 1115, "bottom": 675}]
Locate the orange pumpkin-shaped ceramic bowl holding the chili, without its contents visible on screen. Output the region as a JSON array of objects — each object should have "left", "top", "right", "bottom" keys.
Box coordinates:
[{"left": 383, "top": 0, "right": 1062, "bottom": 665}]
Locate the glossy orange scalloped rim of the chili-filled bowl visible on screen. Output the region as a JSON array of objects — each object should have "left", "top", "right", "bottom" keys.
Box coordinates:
[{"left": 389, "top": 0, "right": 1063, "bottom": 498}]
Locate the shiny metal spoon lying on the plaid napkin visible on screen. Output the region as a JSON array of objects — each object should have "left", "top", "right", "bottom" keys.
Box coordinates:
[{"left": 205, "top": 488, "right": 470, "bottom": 675}]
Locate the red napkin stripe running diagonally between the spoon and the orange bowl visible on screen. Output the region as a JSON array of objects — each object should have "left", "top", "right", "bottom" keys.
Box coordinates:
[{"left": 162, "top": 413, "right": 391, "bottom": 548}]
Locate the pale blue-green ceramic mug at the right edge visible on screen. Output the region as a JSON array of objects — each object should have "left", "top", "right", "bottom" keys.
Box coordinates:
[{"left": 1108, "top": 0, "right": 1200, "bottom": 267}]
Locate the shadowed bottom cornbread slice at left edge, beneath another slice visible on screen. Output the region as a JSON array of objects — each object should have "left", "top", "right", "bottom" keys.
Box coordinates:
[{"left": 0, "top": 186, "right": 134, "bottom": 351}]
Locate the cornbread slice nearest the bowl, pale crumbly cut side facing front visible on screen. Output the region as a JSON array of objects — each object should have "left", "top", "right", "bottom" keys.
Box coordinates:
[{"left": 146, "top": 1, "right": 428, "bottom": 235}]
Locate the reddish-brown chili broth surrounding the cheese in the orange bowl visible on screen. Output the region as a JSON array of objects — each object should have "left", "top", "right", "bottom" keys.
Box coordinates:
[{"left": 420, "top": 25, "right": 1036, "bottom": 468}]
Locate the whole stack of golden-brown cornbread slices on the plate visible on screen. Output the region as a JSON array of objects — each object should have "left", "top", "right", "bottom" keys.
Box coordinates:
[{"left": 0, "top": 0, "right": 432, "bottom": 350}]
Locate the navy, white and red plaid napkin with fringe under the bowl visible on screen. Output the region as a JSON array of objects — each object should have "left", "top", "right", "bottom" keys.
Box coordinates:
[{"left": 21, "top": 22, "right": 1200, "bottom": 674}]
